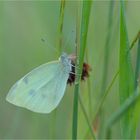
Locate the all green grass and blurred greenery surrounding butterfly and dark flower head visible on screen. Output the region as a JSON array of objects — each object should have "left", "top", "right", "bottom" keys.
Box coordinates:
[{"left": 0, "top": 0, "right": 140, "bottom": 139}]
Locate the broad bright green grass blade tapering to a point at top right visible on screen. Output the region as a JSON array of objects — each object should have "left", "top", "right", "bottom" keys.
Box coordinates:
[{"left": 119, "top": 1, "right": 134, "bottom": 138}]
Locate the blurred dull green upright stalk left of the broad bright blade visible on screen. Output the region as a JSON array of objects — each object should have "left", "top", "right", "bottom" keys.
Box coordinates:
[{"left": 98, "top": 0, "right": 114, "bottom": 138}]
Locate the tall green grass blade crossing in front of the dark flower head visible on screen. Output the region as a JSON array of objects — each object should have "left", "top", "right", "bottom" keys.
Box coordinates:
[{"left": 72, "top": 1, "right": 92, "bottom": 139}]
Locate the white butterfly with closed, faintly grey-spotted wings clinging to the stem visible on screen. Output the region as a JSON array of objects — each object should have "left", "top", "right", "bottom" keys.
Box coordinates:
[{"left": 6, "top": 53, "right": 72, "bottom": 113}]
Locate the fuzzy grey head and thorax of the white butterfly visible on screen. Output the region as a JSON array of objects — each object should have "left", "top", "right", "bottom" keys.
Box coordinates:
[{"left": 59, "top": 53, "right": 71, "bottom": 73}]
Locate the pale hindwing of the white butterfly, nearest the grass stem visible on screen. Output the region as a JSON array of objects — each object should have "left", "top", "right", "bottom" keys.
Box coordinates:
[{"left": 27, "top": 71, "right": 69, "bottom": 113}]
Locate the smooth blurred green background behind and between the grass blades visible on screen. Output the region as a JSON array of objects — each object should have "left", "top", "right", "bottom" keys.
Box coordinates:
[{"left": 0, "top": 1, "right": 140, "bottom": 139}]
